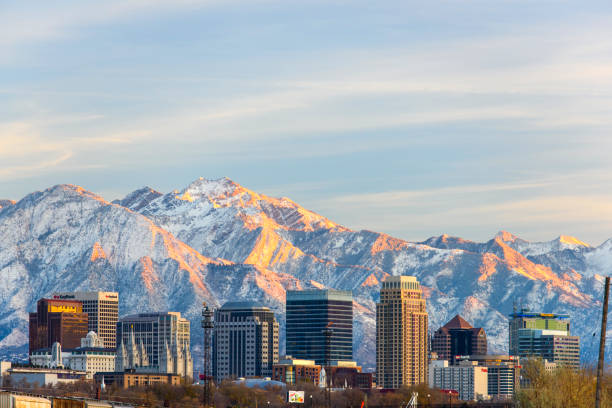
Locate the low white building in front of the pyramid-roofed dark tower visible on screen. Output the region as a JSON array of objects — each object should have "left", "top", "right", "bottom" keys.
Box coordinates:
[{"left": 429, "top": 360, "right": 489, "bottom": 401}]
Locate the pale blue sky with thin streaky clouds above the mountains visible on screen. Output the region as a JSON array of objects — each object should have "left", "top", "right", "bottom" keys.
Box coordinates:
[{"left": 0, "top": 0, "right": 612, "bottom": 245}]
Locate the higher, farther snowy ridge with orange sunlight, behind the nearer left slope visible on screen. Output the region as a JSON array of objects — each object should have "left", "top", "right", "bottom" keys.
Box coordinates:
[{"left": 117, "top": 178, "right": 599, "bottom": 364}]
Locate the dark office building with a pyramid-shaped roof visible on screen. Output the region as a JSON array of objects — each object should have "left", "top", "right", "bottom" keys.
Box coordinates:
[{"left": 431, "top": 315, "right": 487, "bottom": 361}]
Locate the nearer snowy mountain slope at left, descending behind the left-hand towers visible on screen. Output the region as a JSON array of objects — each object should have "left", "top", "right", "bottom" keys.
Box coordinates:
[{"left": 0, "top": 185, "right": 316, "bottom": 360}]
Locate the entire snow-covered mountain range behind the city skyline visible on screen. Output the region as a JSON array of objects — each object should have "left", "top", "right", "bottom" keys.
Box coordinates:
[{"left": 0, "top": 178, "right": 612, "bottom": 368}]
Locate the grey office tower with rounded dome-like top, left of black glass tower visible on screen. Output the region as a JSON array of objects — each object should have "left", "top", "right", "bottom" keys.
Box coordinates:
[{"left": 213, "top": 302, "right": 278, "bottom": 381}]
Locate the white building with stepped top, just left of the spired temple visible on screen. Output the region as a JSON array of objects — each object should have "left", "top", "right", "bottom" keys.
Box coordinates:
[{"left": 30, "top": 332, "right": 115, "bottom": 379}]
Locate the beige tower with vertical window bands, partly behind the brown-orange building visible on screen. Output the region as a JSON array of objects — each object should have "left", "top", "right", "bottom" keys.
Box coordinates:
[{"left": 53, "top": 292, "right": 119, "bottom": 349}]
